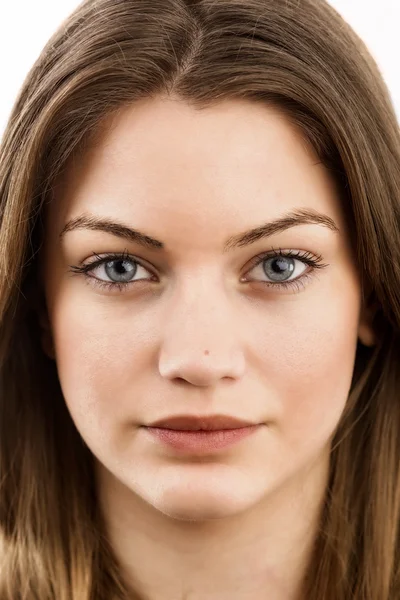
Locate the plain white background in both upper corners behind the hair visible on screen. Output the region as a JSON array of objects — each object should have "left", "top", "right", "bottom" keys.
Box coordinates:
[{"left": 0, "top": 0, "right": 400, "bottom": 138}]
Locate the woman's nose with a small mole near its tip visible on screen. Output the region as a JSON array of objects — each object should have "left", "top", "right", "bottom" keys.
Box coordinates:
[{"left": 159, "top": 273, "right": 245, "bottom": 386}]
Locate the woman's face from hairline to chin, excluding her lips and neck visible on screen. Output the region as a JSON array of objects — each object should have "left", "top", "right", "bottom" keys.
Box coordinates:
[{"left": 42, "top": 98, "right": 376, "bottom": 518}]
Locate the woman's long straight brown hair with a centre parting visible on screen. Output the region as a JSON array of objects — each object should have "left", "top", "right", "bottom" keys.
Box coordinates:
[{"left": 0, "top": 0, "right": 400, "bottom": 600}]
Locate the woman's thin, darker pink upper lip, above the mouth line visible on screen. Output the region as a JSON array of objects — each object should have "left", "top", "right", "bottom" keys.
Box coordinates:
[{"left": 146, "top": 415, "right": 256, "bottom": 431}]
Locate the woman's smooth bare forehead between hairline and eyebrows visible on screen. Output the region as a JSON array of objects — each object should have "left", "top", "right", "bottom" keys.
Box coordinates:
[{"left": 50, "top": 97, "right": 343, "bottom": 237}]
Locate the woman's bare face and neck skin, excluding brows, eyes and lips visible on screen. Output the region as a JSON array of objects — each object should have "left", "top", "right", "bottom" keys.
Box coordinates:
[{"left": 42, "top": 97, "right": 374, "bottom": 600}]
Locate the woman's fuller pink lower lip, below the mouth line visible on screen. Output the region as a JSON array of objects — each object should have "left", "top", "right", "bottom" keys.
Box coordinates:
[{"left": 142, "top": 425, "right": 261, "bottom": 453}]
